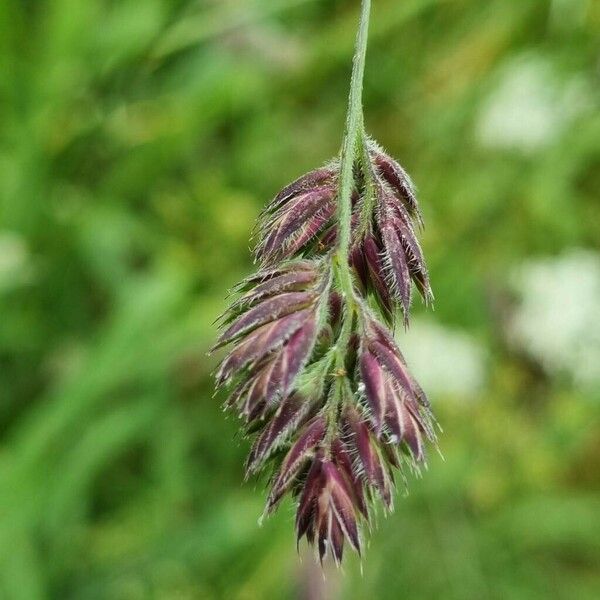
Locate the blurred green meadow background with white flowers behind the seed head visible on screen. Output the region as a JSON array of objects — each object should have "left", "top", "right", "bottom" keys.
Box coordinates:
[{"left": 0, "top": 0, "right": 600, "bottom": 600}]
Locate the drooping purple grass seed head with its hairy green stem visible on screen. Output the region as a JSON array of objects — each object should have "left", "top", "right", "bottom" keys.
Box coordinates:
[{"left": 215, "top": 2, "right": 436, "bottom": 563}]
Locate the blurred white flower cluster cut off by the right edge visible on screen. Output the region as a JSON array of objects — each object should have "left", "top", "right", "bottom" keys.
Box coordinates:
[{"left": 509, "top": 250, "right": 600, "bottom": 386}]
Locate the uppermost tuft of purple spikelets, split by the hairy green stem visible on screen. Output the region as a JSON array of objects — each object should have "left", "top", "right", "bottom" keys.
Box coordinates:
[{"left": 255, "top": 141, "right": 433, "bottom": 325}]
